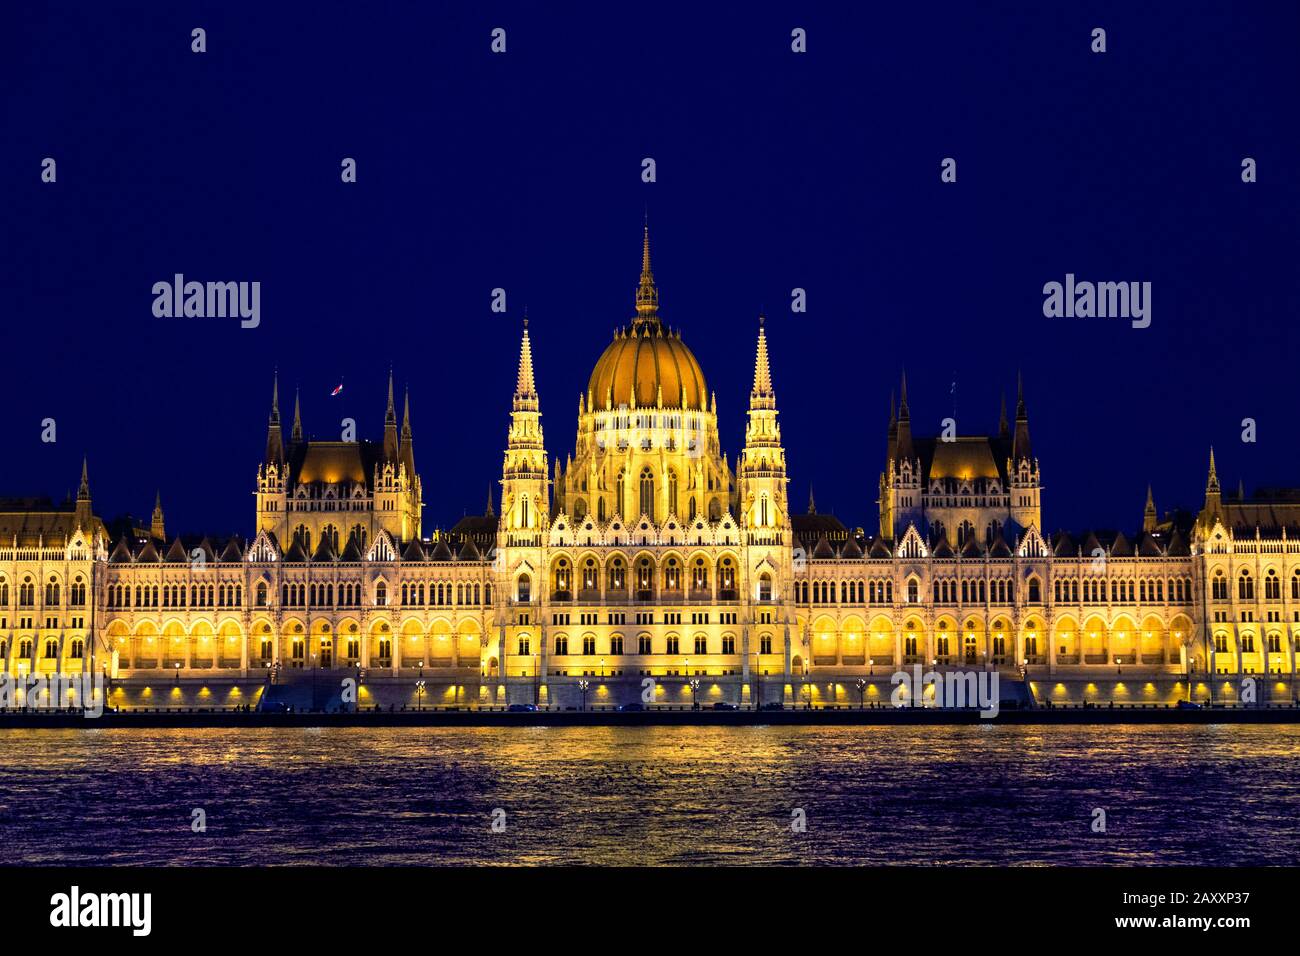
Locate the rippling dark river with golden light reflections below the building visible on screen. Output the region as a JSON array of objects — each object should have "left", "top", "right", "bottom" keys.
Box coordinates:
[{"left": 0, "top": 726, "right": 1300, "bottom": 865}]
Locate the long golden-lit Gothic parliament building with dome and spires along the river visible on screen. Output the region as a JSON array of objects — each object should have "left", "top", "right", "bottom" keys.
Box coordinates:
[{"left": 0, "top": 230, "right": 1300, "bottom": 706}]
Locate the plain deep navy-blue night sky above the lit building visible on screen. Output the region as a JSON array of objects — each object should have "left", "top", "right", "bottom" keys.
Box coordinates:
[{"left": 0, "top": 3, "right": 1300, "bottom": 533}]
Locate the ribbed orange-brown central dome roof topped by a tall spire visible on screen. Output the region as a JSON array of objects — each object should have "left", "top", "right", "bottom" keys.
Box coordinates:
[{"left": 586, "top": 226, "right": 709, "bottom": 411}]
